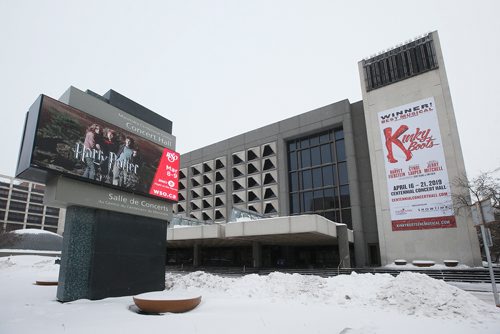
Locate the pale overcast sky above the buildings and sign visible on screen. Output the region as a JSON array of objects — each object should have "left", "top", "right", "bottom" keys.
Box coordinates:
[{"left": 0, "top": 0, "right": 500, "bottom": 180}]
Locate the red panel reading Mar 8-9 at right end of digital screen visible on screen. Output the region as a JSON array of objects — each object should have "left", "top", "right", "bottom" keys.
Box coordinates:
[{"left": 149, "top": 148, "right": 180, "bottom": 202}]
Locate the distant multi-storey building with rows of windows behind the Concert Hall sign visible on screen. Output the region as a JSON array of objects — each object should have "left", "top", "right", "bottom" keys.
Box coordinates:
[{"left": 0, "top": 175, "right": 64, "bottom": 235}]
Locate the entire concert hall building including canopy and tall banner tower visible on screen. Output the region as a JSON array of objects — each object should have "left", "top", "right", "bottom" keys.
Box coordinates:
[{"left": 167, "top": 32, "right": 481, "bottom": 267}]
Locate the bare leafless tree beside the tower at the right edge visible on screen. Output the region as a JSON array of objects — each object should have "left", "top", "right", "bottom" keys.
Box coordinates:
[{"left": 452, "top": 168, "right": 500, "bottom": 262}]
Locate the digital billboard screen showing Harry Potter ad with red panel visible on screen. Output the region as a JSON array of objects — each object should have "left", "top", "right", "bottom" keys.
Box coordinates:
[{"left": 22, "top": 95, "right": 180, "bottom": 201}]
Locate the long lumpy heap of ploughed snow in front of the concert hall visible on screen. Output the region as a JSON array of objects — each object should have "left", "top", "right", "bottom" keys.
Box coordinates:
[{"left": 166, "top": 271, "right": 499, "bottom": 321}]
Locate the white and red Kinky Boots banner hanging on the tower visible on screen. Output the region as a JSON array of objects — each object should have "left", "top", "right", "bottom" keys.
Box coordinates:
[{"left": 378, "top": 97, "right": 456, "bottom": 231}]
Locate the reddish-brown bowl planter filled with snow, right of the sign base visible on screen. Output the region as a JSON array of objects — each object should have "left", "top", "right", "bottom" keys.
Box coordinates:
[{"left": 133, "top": 291, "right": 201, "bottom": 313}]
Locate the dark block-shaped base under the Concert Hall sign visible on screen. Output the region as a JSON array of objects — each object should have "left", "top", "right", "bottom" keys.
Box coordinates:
[{"left": 57, "top": 206, "right": 167, "bottom": 302}]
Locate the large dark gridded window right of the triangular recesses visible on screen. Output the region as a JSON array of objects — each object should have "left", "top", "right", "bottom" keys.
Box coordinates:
[{"left": 286, "top": 128, "right": 352, "bottom": 228}]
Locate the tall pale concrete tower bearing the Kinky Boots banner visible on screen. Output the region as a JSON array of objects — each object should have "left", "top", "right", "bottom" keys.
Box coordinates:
[{"left": 358, "top": 32, "right": 481, "bottom": 266}]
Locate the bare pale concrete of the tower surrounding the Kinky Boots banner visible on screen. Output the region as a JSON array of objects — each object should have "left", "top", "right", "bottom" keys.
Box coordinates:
[{"left": 359, "top": 32, "right": 481, "bottom": 266}]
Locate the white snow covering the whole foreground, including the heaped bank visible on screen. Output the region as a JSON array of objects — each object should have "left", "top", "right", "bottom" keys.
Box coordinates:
[{"left": 0, "top": 255, "right": 500, "bottom": 334}]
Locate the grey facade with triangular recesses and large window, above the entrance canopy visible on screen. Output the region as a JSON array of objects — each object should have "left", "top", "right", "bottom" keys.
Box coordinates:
[{"left": 170, "top": 100, "right": 372, "bottom": 265}]
